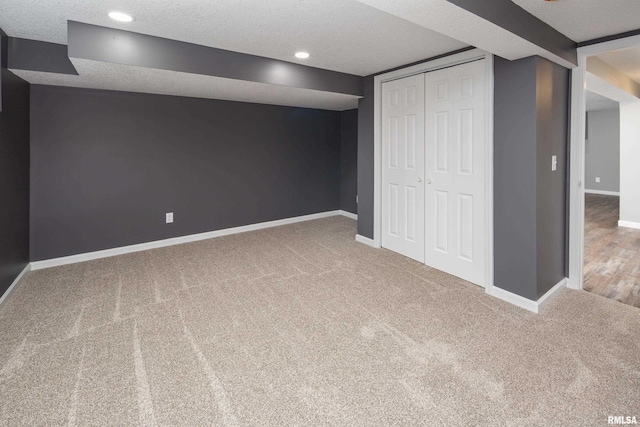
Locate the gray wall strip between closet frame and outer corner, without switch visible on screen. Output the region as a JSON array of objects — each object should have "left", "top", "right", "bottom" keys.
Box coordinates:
[{"left": 494, "top": 57, "right": 537, "bottom": 300}]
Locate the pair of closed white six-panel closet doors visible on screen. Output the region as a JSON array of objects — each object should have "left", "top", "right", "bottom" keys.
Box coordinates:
[{"left": 382, "top": 61, "right": 487, "bottom": 286}]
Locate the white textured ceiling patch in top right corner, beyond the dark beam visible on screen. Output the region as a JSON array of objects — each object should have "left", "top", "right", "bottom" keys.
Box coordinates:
[{"left": 512, "top": 0, "right": 640, "bottom": 42}]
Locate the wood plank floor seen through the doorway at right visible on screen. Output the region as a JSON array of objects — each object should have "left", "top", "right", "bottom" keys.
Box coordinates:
[{"left": 583, "top": 194, "right": 640, "bottom": 307}]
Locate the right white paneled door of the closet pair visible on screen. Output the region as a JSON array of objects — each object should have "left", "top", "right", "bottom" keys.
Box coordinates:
[{"left": 425, "top": 61, "right": 487, "bottom": 286}]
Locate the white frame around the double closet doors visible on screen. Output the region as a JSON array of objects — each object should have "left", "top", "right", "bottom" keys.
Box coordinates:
[{"left": 372, "top": 49, "right": 493, "bottom": 293}]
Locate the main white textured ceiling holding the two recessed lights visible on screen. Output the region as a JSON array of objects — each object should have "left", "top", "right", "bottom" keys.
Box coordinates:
[{"left": 0, "top": 0, "right": 466, "bottom": 76}]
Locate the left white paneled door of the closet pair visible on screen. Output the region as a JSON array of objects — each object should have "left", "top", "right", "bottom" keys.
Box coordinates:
[{"left": 382, "top": 74, "right": 425, "bottom": 262}]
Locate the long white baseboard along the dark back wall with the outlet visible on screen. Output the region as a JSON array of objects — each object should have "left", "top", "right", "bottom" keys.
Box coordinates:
[{"left": 31, "top": 210, "right": 342, "bottom": 270}]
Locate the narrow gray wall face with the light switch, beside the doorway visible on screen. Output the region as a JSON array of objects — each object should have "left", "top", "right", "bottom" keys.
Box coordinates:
[{"left": 535, "top": 57, "right": 570, "bottom": 299}]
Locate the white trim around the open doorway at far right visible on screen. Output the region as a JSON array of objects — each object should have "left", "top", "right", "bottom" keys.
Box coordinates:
[{"left": 567, "top": 36, "right": 640, "bottom": 289}]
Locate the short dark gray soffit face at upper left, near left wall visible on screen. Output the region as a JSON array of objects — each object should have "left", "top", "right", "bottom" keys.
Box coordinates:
[{"left": 8, "top": 37, "right": 78, "bottom": 75}]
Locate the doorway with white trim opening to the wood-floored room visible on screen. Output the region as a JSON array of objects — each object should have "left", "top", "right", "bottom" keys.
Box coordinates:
[{"left": 568, "top": 36, "right": 640, "bottom": 307}]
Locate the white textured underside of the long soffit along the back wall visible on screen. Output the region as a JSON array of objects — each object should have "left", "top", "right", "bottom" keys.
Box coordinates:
[{"left": 13, "top": 58, "right": 358, "bottom": 111}]
